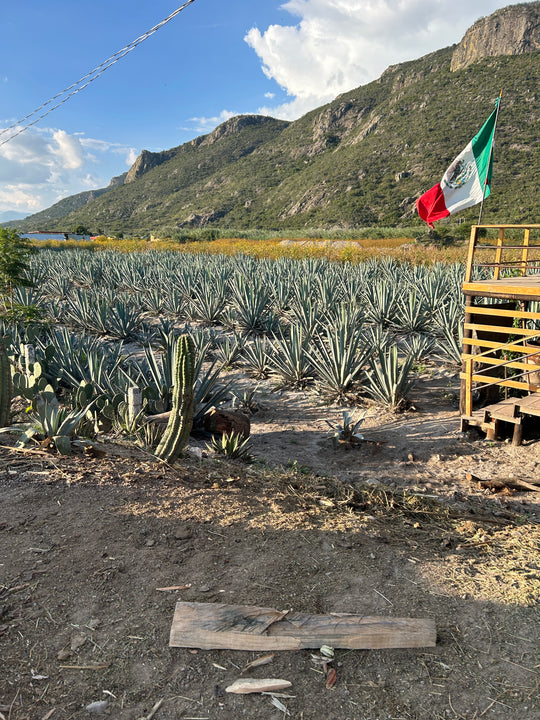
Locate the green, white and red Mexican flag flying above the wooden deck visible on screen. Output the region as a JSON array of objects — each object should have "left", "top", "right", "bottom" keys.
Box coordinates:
[{"left": 416, "top": 98, "right": 499, "bottom": 227}]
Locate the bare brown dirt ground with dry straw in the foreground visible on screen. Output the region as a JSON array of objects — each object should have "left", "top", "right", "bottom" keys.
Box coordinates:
[{"left": 0, "top": 372, "right": 540, "bottom": 720}]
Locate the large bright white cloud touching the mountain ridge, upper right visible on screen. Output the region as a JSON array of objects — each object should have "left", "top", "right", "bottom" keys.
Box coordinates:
[{"left": 245, "top": 0, "right": 507, "bottom": 120}]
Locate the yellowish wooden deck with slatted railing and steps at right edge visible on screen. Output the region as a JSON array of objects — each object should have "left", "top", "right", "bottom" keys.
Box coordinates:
[{"left": 460, "top": 225, "right": 540, "bottom": 444}]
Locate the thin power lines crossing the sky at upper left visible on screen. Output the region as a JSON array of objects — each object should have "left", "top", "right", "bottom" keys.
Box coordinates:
[{"left": 0, "top": 0, "right": 195, "bottom": 147}]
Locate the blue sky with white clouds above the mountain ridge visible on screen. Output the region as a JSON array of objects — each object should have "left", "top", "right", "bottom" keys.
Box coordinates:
[{"left": 0, "top": 0, "right": 509, "bottom": 220}]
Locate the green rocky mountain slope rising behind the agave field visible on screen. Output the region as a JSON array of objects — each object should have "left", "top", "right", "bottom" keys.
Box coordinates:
[{"left": 9, "top": 2, "right": 540, "bottom": 236}]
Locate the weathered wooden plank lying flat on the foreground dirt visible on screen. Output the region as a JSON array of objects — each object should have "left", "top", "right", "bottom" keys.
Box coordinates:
[{"left": 169, "top": 602, "right": 436, "bottom": 650}]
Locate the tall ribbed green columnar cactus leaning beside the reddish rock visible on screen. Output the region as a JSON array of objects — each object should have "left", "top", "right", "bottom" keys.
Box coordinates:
[{"left": 156, "top": 335, "right": 195, "bottom": 463}]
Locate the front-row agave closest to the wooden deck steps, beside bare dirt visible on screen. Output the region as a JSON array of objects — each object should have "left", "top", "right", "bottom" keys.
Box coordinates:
[{"left": 366, "top": 345, "right": 414, "bottom": 411}]
